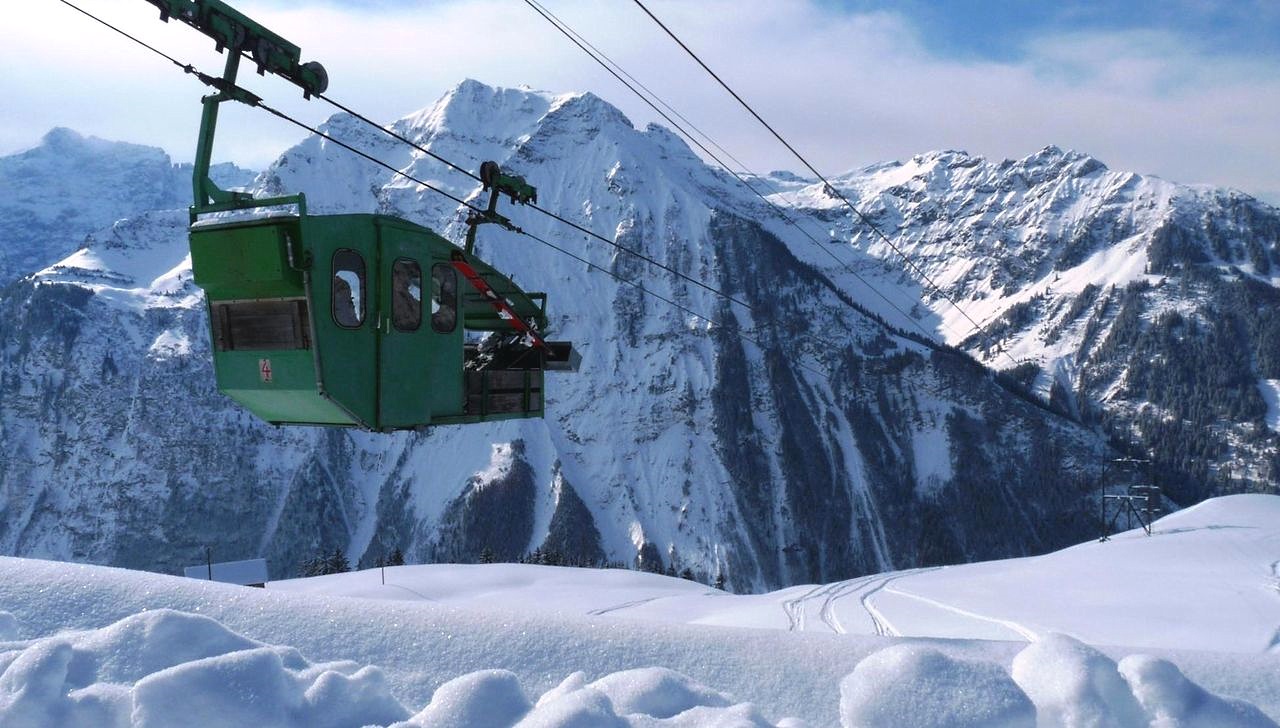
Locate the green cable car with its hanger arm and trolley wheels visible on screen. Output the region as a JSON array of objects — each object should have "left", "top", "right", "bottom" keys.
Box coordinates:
[{"left": 147, "top": 0, "right": 577, "bottom": 431}]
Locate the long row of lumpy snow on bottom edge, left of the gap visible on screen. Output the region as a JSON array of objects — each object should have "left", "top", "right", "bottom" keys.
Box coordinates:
[{"left": 0, "top": 609, "right": 795, "bottom": 728}]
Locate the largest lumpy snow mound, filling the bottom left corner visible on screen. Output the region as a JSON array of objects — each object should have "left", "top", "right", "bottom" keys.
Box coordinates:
[{"left": 0, "top": 609, "right": 408, "bottom": 728}]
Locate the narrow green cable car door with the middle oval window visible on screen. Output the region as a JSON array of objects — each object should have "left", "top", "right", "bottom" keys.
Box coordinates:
[{"left": 378, "top": 224, "right": 431, "bottom": 430}]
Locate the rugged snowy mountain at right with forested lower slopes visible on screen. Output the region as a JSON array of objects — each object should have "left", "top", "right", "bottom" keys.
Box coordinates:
[{"left": 767, "top": 147, "right": 1280, "bottom": 503}]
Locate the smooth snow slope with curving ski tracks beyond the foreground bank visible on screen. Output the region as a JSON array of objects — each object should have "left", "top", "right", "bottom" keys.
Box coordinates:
[{"left": 277, "top": 495, "right": 1280, "bottom": 652}]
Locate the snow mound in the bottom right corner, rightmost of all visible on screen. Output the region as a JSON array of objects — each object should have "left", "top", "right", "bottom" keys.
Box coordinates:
[{"left": 1119, "top": 655, "right": 1277, "bottom": 728}]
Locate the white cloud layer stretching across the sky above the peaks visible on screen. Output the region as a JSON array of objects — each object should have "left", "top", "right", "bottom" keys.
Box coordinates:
[{"left": 0, "top": 0, "right": 1280, "bottom": 202}]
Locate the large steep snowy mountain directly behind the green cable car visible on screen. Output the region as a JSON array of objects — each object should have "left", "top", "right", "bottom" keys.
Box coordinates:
[{"left": 0, "top": 82, "right": 1162, "bottom": 590}]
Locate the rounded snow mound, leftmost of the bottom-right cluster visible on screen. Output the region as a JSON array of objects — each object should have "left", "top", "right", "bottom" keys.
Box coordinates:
[{"left": 840, "top": 644, "right": 1036, "bottom": 728}]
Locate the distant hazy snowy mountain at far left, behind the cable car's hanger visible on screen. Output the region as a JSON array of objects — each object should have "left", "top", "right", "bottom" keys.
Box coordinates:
[{"left": 0, "top": 128, "right": 253, "bottom": 285}]
